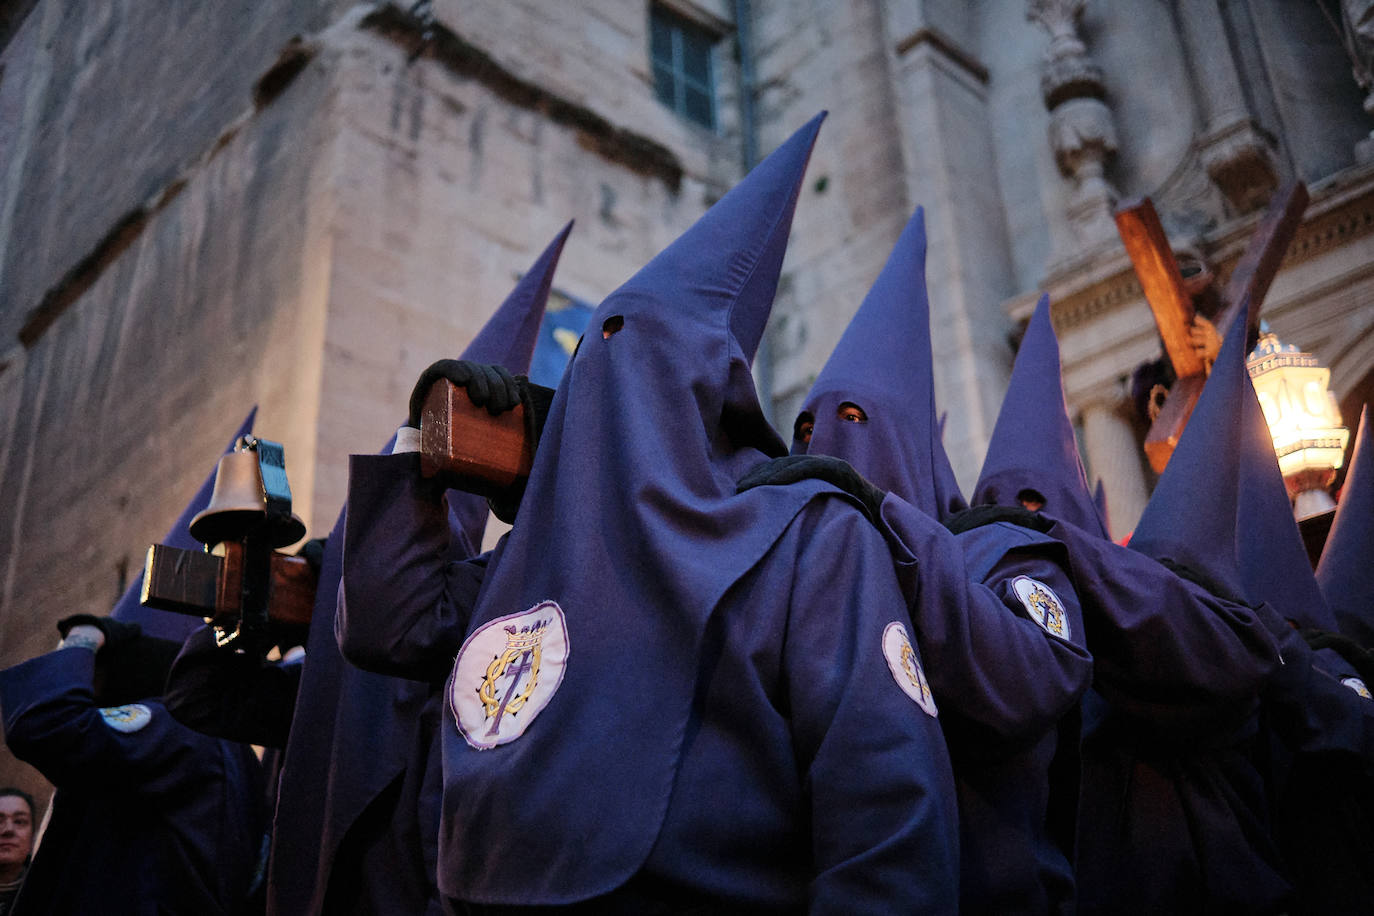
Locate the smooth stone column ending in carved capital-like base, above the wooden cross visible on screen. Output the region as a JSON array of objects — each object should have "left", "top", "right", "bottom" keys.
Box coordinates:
[{"left": 1178, "top": 0, "right": 1279, "bottom": 213}]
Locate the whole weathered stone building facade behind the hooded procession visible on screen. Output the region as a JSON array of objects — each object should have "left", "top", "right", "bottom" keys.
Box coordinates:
[{"left": 0, "top": 0, "right": 1374, "bottom": 783}]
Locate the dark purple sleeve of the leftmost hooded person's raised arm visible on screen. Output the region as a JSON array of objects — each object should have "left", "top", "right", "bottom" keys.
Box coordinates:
[{"left": 0, "top": 648, "right": 223, "bottom": 797}]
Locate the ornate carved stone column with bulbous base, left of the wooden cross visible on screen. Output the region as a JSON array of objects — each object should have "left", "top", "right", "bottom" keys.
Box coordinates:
[{"left": 1026, "top": 0, "right": 1117, "bottom": 244}]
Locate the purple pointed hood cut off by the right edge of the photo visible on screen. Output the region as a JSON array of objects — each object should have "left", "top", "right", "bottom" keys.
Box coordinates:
[{"left": 1316, "top": 407, "right": 1374, "bottom": 648}]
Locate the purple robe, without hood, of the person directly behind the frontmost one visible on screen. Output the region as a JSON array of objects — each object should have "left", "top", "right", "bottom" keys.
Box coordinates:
[{"left": 882, "top": 505, "right": 1092, "bottom": 913}]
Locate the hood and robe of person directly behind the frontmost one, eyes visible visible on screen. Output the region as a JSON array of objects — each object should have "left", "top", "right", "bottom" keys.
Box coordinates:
[{"left": 793, "top": 209, "right": 1092, "bottom": 913}]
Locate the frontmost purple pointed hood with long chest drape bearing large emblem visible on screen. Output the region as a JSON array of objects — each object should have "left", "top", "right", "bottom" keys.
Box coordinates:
[{"left": 440, "top": 117, "right": 820, "bottom": 902}]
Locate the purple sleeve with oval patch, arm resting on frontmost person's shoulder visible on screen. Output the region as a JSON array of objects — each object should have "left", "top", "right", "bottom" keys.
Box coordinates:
[{"left": 882, "top": 499, "right": 1092, "bottom": 743}]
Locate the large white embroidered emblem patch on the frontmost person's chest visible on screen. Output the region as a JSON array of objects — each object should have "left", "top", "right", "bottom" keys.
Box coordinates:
[{"left": 448, "top": 602, "right": 569, "bottom": 751}]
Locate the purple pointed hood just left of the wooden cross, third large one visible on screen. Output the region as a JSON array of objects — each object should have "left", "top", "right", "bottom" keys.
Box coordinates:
[{"left": 973, "top": 295, "right": 1107, "bottom": 537}]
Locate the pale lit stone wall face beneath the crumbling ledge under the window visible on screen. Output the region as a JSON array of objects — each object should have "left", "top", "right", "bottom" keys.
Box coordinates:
[{"left": 312, "top": 7, "right": 738, "bottom": 527}]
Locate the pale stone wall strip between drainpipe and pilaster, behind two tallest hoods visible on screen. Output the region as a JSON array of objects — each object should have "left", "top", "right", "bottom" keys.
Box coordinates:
[{"left": 754, "top": 3, "right": 914, "bottom": 438}]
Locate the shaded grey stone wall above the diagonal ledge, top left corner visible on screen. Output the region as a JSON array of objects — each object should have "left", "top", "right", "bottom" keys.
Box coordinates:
[{"left": 0, "top": 0, "right": 348, "bottom": 346}]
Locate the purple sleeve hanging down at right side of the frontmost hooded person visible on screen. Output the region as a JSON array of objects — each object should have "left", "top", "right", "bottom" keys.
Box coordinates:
[{"left": 783, "top": 500, "right": 959, "bottom": 913}]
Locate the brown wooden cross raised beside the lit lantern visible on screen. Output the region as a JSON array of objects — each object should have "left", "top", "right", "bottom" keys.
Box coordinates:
[{"left": 1116, "top": 180, "right": 1308, "bottom": 474}]
